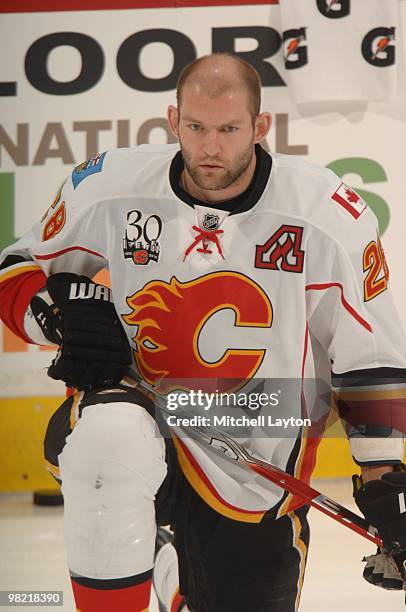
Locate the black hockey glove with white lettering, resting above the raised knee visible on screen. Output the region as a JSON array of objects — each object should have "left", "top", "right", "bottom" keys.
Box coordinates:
[{"left": 30, "top": 273, "right": 131, "bottom": 389}]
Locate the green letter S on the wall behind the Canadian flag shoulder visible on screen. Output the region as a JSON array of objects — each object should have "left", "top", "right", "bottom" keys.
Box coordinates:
[{"left": 327, "top": 157, "right": 390, "bottom": 235}]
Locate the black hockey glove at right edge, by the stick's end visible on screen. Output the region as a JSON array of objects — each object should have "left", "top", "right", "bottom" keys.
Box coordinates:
[{"left": 352, "top": 466, "right": 406, "bottom": 589}]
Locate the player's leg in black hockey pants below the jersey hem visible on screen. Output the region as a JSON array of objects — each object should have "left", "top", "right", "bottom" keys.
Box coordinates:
[{"left": 168, "top": 487, "right": 309, "bottom": 612}]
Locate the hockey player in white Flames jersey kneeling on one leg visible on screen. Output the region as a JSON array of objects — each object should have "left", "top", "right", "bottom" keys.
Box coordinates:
[{"left": 0, "top": 54, "right": 406, "bottom": 612}]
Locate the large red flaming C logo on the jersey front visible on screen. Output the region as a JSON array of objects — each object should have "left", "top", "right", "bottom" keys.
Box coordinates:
[{"left": 123, "top": 272, "right": 272, "bottom": 393}]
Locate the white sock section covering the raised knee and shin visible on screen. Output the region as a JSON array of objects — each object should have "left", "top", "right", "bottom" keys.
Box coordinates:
[{"left": 58, "top": 402, "right": 167, "bottom": 579}]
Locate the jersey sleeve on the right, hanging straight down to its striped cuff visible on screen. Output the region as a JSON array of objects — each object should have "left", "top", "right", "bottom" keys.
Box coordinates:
[{"left": 306, "top": 204, "right": 406, "bottom": 465}]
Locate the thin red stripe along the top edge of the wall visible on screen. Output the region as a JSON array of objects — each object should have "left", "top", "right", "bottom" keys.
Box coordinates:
[{"left": 0, "top": 0, "right": 279, "bottom": 13}]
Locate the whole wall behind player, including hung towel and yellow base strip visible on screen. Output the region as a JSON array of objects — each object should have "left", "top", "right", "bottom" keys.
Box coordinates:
[{"left": 0, "top": 0, "right": 406, "bottom": 491}]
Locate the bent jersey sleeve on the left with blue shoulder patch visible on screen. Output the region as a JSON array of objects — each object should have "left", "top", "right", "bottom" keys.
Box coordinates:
[{"left": 0, "top": 153, "right": 108, "bottom": 342}]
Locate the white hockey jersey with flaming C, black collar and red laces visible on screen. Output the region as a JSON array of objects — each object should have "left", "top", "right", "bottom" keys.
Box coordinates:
[{"left": 0, "top": 145, "right": 406, "bottom": 522}]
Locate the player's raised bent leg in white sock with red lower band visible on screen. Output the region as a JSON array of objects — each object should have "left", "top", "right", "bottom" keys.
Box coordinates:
[{"left": 46, "top": 390, "right": 167, "bottom": 612}]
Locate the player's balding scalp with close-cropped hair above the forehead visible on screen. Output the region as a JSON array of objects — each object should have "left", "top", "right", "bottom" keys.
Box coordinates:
[{"left": 176, "top": 53, "right": 261, "bottom": 119}]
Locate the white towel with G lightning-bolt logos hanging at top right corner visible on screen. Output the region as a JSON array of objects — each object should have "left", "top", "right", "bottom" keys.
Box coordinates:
[{"left": 280, "top": 0, "right": 400, "bottom": 103}]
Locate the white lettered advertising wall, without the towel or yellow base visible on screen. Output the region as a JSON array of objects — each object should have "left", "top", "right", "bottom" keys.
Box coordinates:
[{"left": 0, "top": 0, "right": 406, "bottom": 388}]
